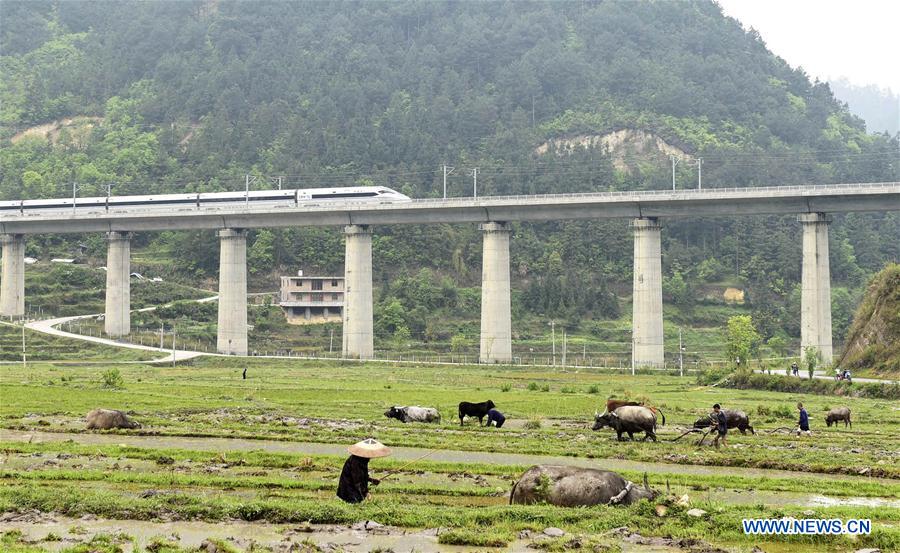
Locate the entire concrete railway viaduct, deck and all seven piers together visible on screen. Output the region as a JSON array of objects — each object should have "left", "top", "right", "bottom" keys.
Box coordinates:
[{"left": 0, "top": 182, "right": 900, "bottom": 366}]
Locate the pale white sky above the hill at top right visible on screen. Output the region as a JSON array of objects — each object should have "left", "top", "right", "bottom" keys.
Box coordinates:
[{"left": 718, "top": 0, "right": 900, "bottom": 93}]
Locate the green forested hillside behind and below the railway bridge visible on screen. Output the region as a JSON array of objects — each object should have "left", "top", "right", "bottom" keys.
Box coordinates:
[{"left": 0, "top": 0, "right": 900, "bottom": 356}]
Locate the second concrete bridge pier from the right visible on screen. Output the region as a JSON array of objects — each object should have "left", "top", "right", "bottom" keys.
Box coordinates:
[{"left": 631, "top": 217, "right": 665, "bottom": 367}]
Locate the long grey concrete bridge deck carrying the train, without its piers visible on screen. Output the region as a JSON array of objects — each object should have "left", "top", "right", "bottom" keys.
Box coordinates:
[{"left": 0, "top": 182, "right": 900, "bottom": 234}]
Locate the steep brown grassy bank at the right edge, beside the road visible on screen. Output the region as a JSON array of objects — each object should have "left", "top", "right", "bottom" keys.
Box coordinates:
[{"left": 838, "top": 263, "right": 900, "bottom": 373}]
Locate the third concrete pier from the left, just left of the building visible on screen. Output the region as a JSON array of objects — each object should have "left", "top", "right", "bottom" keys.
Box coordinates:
[{"left": 216, "top": 229, "right": 247, "bottom": 355}]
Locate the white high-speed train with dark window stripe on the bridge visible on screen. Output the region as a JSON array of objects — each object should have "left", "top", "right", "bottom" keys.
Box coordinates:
[{"left": 0, "top": 186, "right": 410, "bottom": 214}]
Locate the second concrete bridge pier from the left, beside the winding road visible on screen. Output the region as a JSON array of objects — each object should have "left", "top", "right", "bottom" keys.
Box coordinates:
[{"left": 104, "top": 232, "right": 131, "bottom": 337}]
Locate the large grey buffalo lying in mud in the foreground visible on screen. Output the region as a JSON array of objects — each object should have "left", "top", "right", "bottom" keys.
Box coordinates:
[{"left": 509, "top": 465, "right": 658, "bottom": 507}]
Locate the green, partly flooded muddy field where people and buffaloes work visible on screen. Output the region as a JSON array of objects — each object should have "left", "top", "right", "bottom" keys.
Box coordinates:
[{"left": 0, "top": 360, "right": 900, "bottom": 552}]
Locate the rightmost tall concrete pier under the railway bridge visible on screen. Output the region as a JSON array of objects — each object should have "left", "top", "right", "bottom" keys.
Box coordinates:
[{"left": 797, "top": 213, "right": 834, "bottom": 365}]
